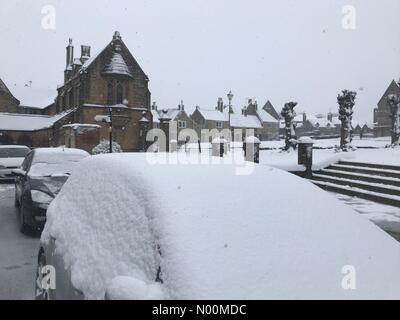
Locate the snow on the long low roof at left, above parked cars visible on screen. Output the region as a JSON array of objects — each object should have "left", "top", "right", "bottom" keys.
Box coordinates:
[{"left": 0, "top": 110, "right": 74, "bottom": 131}]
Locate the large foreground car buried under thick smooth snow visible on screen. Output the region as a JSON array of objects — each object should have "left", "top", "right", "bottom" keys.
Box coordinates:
[{"left": 36, "top": 153, "right": 400, "bottom": 300}]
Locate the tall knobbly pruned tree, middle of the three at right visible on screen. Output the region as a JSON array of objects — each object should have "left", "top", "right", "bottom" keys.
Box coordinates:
[{"left": 337, "top": 90, "right": 357, "bottom": 151}]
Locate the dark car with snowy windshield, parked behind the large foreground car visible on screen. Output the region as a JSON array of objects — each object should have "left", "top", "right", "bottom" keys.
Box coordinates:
[{"left": 13, "top": 148, "right": 89, "bottom": 233}]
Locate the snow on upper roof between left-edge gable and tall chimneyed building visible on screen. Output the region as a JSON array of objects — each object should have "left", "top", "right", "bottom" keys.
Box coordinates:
[{"left": 9, "top": 84, "right": 57, "bottom": 109}]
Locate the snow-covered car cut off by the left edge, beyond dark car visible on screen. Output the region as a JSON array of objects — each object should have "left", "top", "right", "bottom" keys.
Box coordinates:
[{"left": 0, "top": 146, "right": 31, "bottom": 181}]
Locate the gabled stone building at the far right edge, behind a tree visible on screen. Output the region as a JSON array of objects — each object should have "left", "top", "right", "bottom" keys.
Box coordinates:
[{"left": 374, "top": 80, "right": 400, "bottom": 137}]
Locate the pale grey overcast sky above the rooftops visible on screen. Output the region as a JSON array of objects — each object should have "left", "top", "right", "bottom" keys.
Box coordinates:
[{"left": 0, "top": 0, "right": 400, "bottom": 121}]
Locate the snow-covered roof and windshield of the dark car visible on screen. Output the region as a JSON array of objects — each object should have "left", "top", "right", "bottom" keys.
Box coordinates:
[{"left": 29, "top": 153, "right": 86, "bottom": 177}]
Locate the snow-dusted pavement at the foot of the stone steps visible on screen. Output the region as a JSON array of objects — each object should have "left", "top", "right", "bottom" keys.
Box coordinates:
[{"left": 333, "top": 193, "right": 400, "bottom": 241}]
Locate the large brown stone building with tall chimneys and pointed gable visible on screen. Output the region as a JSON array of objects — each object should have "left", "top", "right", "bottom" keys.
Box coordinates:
[{"left": 0, "top": 32, "right": 152, "bottom": 151}]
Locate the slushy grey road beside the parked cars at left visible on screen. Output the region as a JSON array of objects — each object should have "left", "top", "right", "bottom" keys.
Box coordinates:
[{"left": 0, "top": 184, "right": 39, "bottom": 300}]
